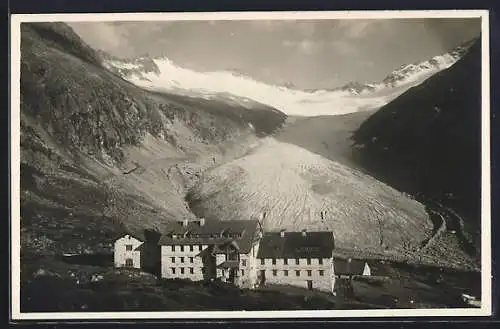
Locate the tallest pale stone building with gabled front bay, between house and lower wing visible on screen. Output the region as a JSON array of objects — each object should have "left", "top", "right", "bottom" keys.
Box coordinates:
[{"left": 159, "top": 219, "right": 260, "bottom": 288}]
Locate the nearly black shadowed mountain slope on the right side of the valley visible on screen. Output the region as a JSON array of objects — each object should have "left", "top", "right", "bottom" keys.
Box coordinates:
[{"left": 354, "top": 41, "right": 481, "bottom": 241}]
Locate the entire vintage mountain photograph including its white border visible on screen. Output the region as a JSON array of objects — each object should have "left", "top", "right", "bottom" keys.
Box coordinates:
[{"left": 11, "top": 11, "right": 491, "bottom": 319}]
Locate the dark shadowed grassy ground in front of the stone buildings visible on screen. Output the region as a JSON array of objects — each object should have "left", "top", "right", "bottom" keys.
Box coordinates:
[{"left": 21, "top": 257, "right": 480, "bottom": 312}]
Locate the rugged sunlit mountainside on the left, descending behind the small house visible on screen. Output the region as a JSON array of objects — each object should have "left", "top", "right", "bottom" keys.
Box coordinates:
[{"left": 20, "top": 23, "right": 285, "bottom": 253}]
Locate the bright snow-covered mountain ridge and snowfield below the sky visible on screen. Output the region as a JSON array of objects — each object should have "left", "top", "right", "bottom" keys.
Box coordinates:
[{"left": 104, "top": 38, "right": 472, "bottom": 116}]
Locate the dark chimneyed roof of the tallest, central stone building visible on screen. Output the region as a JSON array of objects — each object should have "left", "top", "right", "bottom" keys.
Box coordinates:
[{"left": 159, "top": 220, "right": 259, "bottom": 253}]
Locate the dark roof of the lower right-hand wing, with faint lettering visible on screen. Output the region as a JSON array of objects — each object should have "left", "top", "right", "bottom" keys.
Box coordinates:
[{"left": 257, "top": 232, "right": 335, "bottom": 258}]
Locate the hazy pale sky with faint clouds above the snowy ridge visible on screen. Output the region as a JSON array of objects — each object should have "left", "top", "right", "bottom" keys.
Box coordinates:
[{"left": 69, "top": 18, "right": 481, "bottom": 89}]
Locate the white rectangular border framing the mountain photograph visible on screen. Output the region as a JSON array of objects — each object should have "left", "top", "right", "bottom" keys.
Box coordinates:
[{"left": 10, "top": 10, "right": 492, "bottom": 320}]
